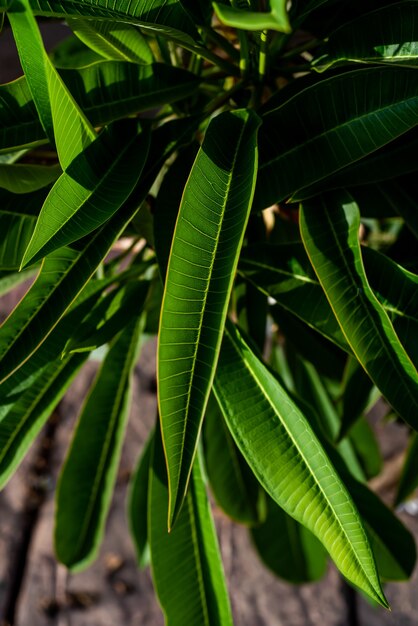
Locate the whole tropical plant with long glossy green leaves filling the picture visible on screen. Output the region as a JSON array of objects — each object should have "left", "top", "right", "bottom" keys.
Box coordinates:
[{"left": 0, "top": 0, "right": 418, "bottom": 626}]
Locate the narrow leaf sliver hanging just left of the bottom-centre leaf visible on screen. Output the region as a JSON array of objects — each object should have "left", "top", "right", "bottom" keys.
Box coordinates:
[{"left": 127, "top": 431, "right": 154, "bottom": 569}]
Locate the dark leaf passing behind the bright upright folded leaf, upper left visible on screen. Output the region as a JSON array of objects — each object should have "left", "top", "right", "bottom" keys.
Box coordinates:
[{"left": 0, "top": 61, "right": 199, "bottom": 151}]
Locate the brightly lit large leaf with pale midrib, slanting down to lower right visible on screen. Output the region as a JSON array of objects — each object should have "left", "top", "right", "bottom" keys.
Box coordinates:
[{"left": 214, "top": 324, "right": 387, "bottom": 606}]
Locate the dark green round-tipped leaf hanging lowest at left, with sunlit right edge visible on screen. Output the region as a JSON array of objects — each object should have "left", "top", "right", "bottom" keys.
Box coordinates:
[{"left": 55, "top": 318, "right": 140, "bottom": 571}]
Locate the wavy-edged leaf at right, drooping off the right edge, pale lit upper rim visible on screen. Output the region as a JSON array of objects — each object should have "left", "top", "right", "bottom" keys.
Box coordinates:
[{"left": 300, "top": 195, "right": 418, "bottom": 428}]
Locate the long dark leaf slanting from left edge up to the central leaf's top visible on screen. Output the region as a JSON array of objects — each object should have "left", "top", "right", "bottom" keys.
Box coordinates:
[{"left": 0, "top": 119, "right": 197, "bottom": 380}]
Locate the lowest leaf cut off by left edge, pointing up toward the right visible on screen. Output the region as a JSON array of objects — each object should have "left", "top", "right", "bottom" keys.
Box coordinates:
[{"left": 0, "top": 355, "right": 87, "bottom": 489}]
